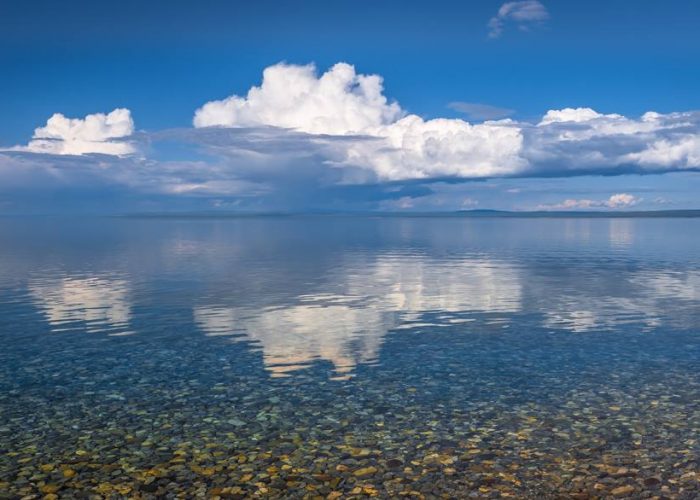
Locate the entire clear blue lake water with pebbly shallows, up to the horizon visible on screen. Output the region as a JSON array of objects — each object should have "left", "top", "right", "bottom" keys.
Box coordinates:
[{"left": 0, "top": 217, "right": 700, "bottom": 498}]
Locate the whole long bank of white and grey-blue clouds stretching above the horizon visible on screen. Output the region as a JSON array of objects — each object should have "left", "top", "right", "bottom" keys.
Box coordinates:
[{"left": 0, "top": 63, "right": 700, "bottom": 209}]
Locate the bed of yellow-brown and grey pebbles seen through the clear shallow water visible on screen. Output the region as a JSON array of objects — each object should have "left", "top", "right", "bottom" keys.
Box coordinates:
[{"left": 0, "top": 322, "right": 700, "bottom": 499}]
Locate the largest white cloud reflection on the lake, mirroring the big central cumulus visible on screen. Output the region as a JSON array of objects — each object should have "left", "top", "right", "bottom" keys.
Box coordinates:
[{"left": 194, "top": 255, "right": 522, "bottom": 378}]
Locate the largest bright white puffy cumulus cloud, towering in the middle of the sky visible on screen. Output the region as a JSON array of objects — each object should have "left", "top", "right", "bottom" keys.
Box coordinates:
[{"left": 194, "top": 63, "right": 525, "bottom": 180}]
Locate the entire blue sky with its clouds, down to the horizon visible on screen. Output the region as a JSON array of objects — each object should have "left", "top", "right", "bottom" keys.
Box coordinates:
[{"left": 0, "top": 0, "right": 700, "bottom": 214}]
